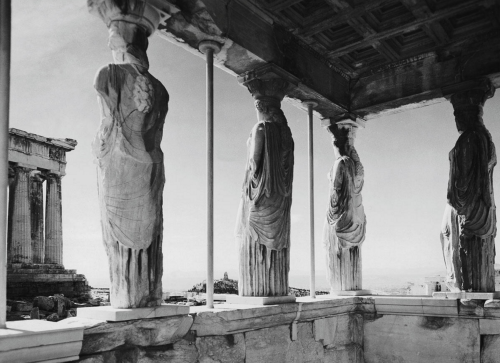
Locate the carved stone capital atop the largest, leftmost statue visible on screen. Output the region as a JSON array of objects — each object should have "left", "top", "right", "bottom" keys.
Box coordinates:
[{"left": 87, "top": 0, "right": 160, "bottom": 36}]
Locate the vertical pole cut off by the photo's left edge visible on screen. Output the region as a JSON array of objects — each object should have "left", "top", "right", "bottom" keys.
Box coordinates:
[{"left": 0, "top": 0, "right": 11, "bottom": 329}]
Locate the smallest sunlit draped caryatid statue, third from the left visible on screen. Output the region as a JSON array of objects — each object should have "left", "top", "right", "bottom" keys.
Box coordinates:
[{"left": 323, "top": 124, "right": 366, "bottom": 293}]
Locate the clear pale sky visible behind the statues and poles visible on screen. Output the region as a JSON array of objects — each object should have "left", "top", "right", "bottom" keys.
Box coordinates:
[{"left": 10, "top": 0, "right": 500, "bottom": 290}]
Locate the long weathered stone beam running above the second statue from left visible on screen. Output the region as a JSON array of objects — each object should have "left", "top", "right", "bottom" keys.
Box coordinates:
[{"left": 154, "top": 0, "right": 350, "bottom": 117}]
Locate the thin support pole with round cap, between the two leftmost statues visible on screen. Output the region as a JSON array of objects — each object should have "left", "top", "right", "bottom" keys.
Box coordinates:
[{"left": 198, "top": 40, "right": 221, "bottom": 309}]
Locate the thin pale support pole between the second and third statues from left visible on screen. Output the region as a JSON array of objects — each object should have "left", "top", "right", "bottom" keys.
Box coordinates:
[{"left": 303, "top": 101, "right": 318, "bottom": 299}]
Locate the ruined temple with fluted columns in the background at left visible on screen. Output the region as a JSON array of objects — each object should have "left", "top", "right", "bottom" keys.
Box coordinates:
[{"left": 7, "top": 129, "right": 88, "bottom": 299}]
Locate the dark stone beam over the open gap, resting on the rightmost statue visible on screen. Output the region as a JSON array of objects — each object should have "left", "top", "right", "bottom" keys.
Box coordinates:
[{"left": 350, "top": 33, "right": 500, "bottom": 119}]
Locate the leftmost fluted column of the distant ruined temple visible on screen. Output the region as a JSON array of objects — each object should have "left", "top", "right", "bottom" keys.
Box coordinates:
[{"left": 8, "top": 166, "right": 32, "bottom": 263}]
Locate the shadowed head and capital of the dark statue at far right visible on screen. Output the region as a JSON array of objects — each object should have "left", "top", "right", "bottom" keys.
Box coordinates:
[{"left": 450, "top": 78, "right": 495, "bottom": 131}]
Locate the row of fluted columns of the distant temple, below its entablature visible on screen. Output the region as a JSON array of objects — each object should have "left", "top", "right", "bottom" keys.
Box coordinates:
[{"left": 7, "top": 165, "right": 63, "bottom": 265}]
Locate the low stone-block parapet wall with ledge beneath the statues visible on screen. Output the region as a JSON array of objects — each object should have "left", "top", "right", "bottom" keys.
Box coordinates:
[{"left": 57, "top": 297, "right": 500, "bottom": 363}]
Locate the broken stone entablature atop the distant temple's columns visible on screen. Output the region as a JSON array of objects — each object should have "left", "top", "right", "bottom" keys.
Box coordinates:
[{"left": 9, "top": 129, "right": 77, "bottom": 176}]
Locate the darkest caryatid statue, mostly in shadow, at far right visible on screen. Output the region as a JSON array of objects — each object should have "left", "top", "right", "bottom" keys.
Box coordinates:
[{"left": 441, "top": 80, "right": 497, "bottom": 292}]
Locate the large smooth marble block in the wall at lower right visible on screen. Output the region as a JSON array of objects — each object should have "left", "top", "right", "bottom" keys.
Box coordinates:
[{"left": 364, "top": 315, "right": 480, "bottom": 363}]
